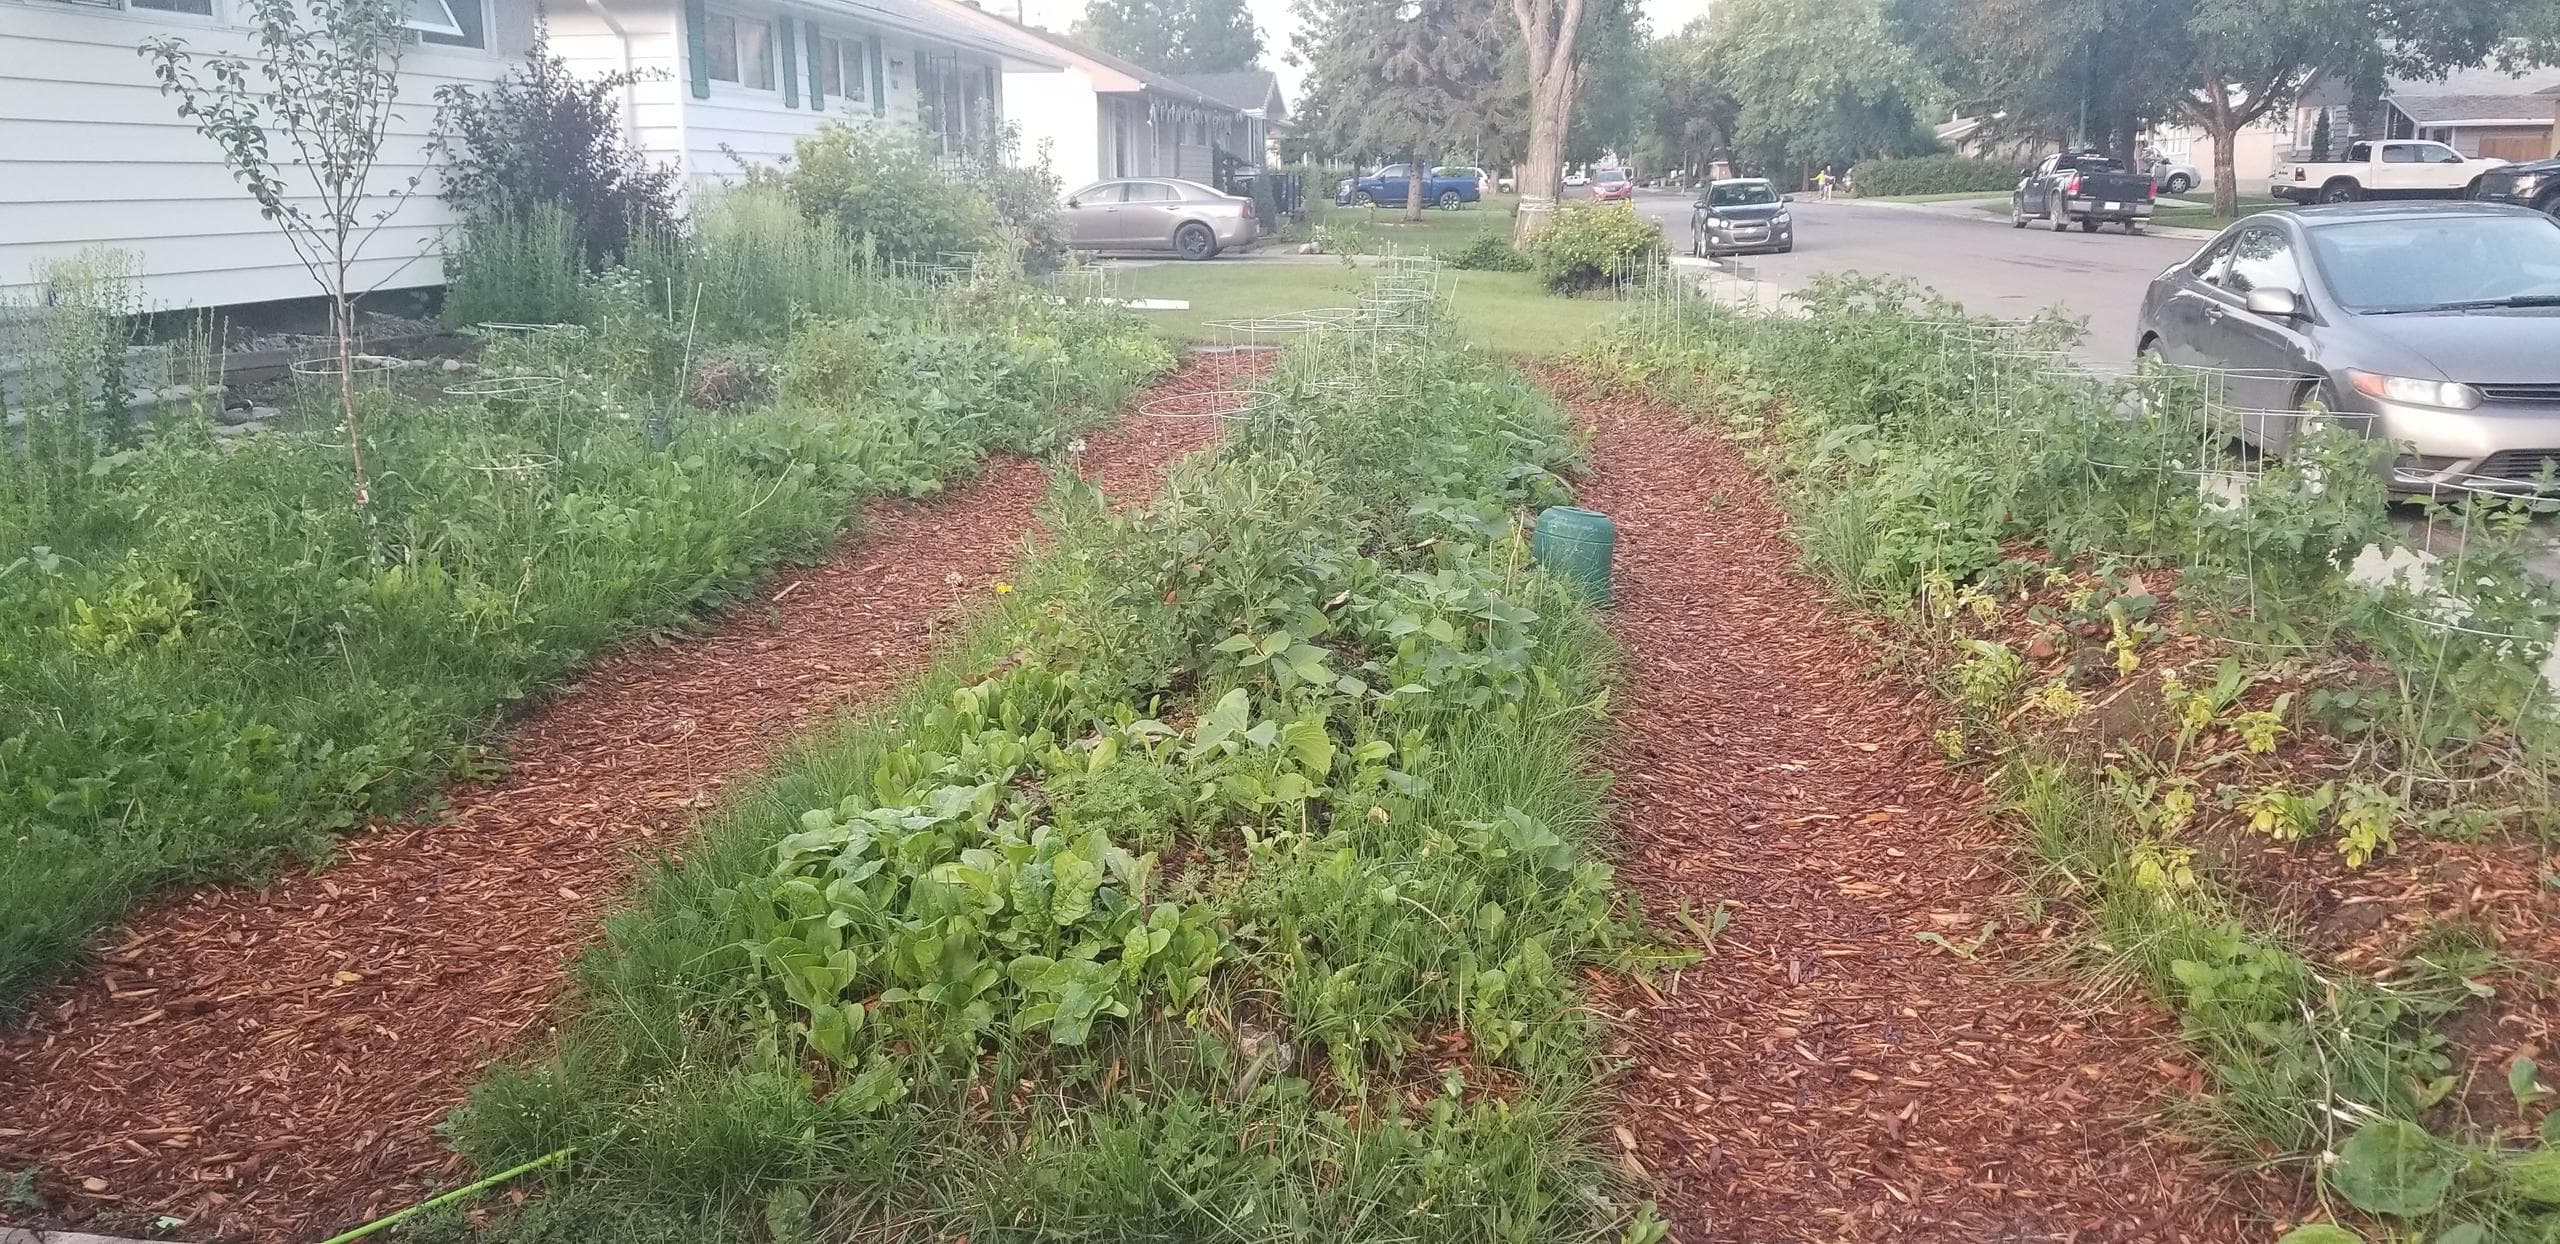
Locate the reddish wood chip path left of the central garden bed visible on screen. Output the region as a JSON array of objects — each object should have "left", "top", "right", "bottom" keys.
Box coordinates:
[{"left": 0, "top": 356, "right": 1262, "bottom": 1241}]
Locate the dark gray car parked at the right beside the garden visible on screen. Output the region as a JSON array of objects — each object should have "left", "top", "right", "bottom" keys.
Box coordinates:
[{"left": 2135, "top": 202, "right": 2560, "bottom": 494}]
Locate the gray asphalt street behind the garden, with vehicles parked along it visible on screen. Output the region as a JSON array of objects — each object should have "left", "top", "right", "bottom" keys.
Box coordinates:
[{"left": 1636, "top": 192, "right": 2204, "bottom": 363}]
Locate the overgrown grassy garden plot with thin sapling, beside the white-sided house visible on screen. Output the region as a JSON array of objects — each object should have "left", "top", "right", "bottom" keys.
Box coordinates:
[{"left": 0, "top": 192, "right": 1167, "bottom": 1009}]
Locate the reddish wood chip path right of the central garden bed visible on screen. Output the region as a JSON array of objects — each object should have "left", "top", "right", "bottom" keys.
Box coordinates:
[{"left": 1546, "top": 374, "right": 2268, "bottom": 1244}]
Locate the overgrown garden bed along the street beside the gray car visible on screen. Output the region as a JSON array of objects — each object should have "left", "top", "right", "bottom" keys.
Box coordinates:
[{"left": 1587, "top": 282, "right": 2560, "bottom": 1241}]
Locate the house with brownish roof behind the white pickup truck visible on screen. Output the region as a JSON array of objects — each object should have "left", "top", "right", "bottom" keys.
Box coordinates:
[{"left": 2289, "top": 67, "right": 2560, "bottom": 161}]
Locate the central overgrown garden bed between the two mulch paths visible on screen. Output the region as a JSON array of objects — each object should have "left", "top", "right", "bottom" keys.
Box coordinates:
[{"left": 432, "top": 281, "right": 1677, "bottom": 1241}]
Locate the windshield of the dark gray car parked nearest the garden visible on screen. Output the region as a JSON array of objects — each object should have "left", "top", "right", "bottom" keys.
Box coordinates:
[{"left": 2309, "top": 215, "right": 2560, "bottom": 315}]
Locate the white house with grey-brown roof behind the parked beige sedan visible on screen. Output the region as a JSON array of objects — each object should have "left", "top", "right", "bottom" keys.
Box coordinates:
[{"left": 909, "top": 0, "right": 1267, "bottom": 189}]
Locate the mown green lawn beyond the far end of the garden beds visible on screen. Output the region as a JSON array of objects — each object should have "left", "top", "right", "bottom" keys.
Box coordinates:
[{"left": 1119, "top": 259, "right": 1620, "bottom": 353}]
